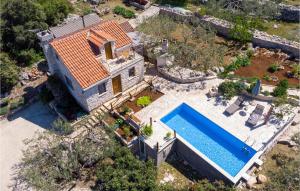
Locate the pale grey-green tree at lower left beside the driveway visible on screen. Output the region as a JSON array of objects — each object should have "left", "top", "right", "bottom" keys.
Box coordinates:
[{"left": 15, "top": 128, "right": 114, "bottom": 190}]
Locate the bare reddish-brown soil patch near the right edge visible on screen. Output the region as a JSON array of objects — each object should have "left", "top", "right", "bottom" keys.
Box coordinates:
[{"left": 235, "top": 48, "right": 300, "bottom": 86}]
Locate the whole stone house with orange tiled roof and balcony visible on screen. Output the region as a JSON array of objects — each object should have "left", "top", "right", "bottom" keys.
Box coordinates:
[{"left": 37, "top": 21, "right": 144, "bottom": 112}]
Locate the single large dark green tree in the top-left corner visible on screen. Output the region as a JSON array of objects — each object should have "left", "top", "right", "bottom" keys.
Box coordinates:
[{"left": 1, "top": 0, "right": 47, "bottom": 64}]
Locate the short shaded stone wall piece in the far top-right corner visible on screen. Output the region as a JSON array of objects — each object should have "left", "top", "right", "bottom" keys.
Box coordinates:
[{"left": 279, "top": 3, "right": 300, "bottom": 22}]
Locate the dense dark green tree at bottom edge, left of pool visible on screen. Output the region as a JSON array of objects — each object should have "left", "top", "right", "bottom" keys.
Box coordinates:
[{"left": 94, "top": 147, "right": 156, "bottom": 191}]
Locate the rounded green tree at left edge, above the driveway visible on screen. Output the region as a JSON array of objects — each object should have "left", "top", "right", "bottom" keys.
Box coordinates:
[{"left": 0, "top": 53, "right": 19, "bottom": 92}]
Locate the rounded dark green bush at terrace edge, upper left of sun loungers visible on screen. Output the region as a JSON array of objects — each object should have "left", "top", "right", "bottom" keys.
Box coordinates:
[{"left": 218, "top": 81, "right": 246, "bottom": 100}]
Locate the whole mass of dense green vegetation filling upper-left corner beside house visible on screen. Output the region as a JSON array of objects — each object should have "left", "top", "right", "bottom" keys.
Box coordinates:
[{"left": 0, "top": 0, "right": 72, "bottom": 92}]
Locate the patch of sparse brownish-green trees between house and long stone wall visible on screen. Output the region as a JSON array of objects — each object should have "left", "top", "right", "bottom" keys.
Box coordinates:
[{"left": 138, "top": 16, "right": 226, "bottom": 72}]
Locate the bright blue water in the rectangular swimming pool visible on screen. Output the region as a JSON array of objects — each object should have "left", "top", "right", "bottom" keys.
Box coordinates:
[{"left": 161, "top": 103, "right": 256, "bottom": 177}]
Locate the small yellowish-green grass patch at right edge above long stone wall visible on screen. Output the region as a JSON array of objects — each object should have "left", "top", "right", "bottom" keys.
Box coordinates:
[{"left": 264, "top": 21, "right": 300, "bottom": 42}]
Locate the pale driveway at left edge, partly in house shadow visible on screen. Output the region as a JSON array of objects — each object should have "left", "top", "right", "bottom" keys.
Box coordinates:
[{"left": 0, "top": 102, "right": 56, "bottom": 191}]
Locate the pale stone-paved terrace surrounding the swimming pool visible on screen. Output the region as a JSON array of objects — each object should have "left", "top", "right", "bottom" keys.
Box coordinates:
[{"left": 136, "top": 78, "right": 293, "bottom": 150}]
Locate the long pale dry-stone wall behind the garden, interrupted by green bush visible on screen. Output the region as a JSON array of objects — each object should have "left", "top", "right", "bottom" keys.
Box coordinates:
[{"left": 159, "top": 7, "right": 300, "bottom": 58}]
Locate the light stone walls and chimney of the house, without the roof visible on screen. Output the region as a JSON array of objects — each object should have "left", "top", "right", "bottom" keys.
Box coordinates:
[{"left": 37, "top": 31, "right": 144, "bottom": 112}]
